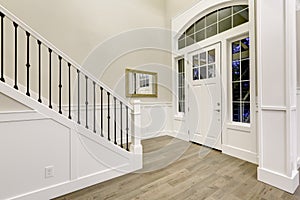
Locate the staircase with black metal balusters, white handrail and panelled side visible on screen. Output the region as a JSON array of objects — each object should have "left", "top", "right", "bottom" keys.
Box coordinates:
[{"left": 0, "top": 6, "right": 142, "bottom": 200}]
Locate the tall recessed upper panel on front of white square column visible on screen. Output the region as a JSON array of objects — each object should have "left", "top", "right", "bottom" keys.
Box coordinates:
[{"left": 260, "top": 0, "right": 286, "bottom": 106}]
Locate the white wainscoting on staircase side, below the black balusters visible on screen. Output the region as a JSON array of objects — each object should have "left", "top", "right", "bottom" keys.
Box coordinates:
[{"left": 0, "top": 110, "right": 142, "bottom": 200}]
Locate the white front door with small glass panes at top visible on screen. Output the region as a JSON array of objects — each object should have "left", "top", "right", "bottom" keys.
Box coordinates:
[{"left": 187, "top": 43, "right": 222, "bottom": 149}]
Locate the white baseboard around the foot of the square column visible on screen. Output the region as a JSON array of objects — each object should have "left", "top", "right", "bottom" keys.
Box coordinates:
[{"left": 257, "top": 167, "right": 299, "bottom": 194}]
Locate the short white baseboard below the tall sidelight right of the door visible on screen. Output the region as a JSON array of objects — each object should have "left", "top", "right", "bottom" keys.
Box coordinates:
[{"left": 222, "top": 144, "right": 258, "bottom": 164}]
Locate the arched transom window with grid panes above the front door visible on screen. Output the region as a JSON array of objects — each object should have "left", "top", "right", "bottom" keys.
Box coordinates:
[{"left": 178, "top": 5, "right": 249, "bottom": 49}]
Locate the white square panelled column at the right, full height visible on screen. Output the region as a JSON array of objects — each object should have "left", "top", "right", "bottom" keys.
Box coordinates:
[{"left": 256, "top": 0, "right": 299, "bottom": 193}]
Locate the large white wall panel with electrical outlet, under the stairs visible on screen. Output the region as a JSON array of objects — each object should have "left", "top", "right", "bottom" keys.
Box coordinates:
[{"left": 0, "top": 119, "right": 70, "bottom": 199}]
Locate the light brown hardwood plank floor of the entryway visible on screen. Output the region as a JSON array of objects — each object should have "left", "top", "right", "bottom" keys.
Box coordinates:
[{"left": 56, "top": 136, "right": 300, "bottom": 200}]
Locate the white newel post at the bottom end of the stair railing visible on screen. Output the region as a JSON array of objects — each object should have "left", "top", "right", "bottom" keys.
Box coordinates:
[{"left": 130, "top": 100, "right": 143, "bottom": 154}]
